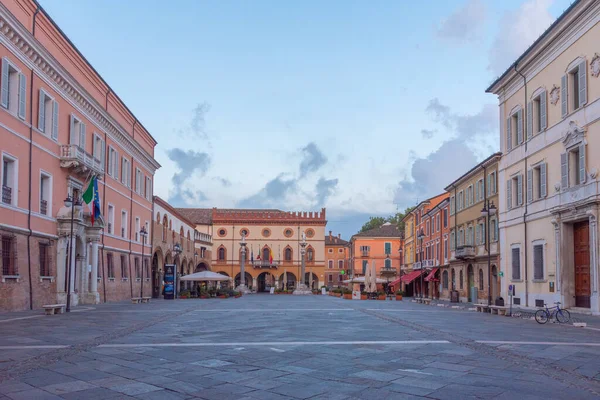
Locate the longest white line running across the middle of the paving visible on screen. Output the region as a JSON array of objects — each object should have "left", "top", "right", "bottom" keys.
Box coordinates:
[{"left": 98, "top": 340, "right": 450, "bottom": 348}]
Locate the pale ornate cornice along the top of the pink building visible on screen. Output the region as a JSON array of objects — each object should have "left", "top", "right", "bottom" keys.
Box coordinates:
[{"left": 0, "top": 3, "right": 160, "bottom": 174}]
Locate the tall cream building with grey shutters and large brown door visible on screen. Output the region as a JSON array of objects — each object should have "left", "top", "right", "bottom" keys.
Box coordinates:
[{"left": 487, "top": 0, "right": 600, "bottom": 314}]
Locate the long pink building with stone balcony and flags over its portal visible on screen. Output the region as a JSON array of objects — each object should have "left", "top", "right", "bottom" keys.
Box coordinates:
[{"left": 0, "top": 0, "right": 159, "bottom": 310}]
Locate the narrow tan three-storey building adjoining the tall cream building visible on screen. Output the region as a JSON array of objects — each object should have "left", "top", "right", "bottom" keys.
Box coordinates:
[{"left": 440, "top": 153, "right": 502, "bottom": 304}]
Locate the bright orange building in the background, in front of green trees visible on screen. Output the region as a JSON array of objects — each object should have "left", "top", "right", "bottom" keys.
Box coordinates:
[{"left": 350, "top": 222, "right": 403, "bottom": 280}]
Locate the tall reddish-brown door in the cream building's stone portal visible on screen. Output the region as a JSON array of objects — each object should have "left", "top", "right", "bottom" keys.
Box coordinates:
[{"left": 573, "top": 221, "right": 591, "bottom": 308}]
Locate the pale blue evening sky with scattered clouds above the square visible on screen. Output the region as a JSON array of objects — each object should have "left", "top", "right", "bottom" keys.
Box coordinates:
[{"left": 40, "top": 0, "right": 570, "bottom": 238}]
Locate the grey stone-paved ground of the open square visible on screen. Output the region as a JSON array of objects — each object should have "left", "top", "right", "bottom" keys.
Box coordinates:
[{"left": 0, "top": 295, "right": 600, "bottom": 400}]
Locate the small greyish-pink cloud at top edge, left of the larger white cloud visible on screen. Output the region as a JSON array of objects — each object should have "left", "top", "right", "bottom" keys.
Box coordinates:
[{"left": 437, "top": 0, "right": 486, "bottom": 43}]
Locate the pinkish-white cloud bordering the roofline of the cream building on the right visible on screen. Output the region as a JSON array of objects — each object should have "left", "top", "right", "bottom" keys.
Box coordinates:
[{"left": 488, "top": 0, "right": 554, "bottom": 75}]
